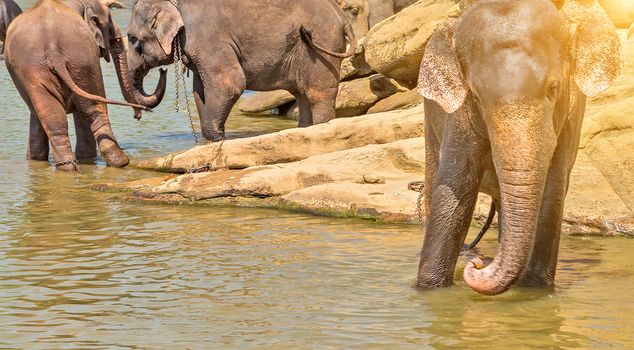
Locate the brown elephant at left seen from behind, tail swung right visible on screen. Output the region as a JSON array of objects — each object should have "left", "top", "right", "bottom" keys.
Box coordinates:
[{"left": 5, "top": 0, "right": 164, "bottom": 171}]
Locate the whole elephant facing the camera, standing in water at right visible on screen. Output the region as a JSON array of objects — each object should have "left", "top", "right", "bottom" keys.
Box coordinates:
[{"left": 418, "top": 0, "right": 621, "bottom": 295}]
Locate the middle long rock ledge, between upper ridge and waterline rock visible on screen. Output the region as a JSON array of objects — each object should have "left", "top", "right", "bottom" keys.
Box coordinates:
[{"left": 139, "top": 138, "right": 425, "bottom": 200}]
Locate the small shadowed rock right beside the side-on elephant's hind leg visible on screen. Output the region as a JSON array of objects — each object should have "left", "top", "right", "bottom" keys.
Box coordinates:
[{"left": 336, "top": 74, "right": 400, "bottom": 118}]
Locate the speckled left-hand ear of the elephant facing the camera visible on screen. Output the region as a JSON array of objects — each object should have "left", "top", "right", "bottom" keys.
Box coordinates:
[{"left": 418, "top": 18, "right": 467, "bottom": 113}]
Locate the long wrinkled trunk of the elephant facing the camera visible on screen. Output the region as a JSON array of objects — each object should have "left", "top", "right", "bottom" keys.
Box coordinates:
[{"left": 464, "top": 103, "right": 556, "bottom": 295}]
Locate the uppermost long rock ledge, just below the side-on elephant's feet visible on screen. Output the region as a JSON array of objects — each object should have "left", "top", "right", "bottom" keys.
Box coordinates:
[{"left": 132, "top": 106, "right": 424, "bottom": 173}]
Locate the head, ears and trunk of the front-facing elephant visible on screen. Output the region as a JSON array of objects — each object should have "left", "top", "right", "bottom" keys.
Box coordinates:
[{"left": 419, "top": 0, "right": 621, "bottom": 295}]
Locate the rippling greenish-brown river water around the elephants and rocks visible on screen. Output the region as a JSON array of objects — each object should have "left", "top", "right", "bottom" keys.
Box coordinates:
[{"left": 0, "top": 1, "right": 634, "bottom": 349}]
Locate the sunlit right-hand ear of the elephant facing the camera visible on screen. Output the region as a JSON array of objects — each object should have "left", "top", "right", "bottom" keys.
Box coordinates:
[{"left": 572, "top": 17, "right": 622, "bottom": 97}]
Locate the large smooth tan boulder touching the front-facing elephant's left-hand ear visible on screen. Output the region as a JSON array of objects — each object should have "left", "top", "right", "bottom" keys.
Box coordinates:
[{"left": 364, "top": 0, "right": 460, "bottom": 88}]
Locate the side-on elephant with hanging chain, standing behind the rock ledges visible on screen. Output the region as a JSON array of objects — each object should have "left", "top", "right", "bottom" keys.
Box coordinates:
[{"left": 128, "top": 0, "right": 356, "bottom": 141}]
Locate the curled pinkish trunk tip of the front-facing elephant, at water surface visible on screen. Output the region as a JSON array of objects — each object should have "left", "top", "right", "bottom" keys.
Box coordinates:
[{"left": 463, "top": 258, "right": 513, "bottom": 296}]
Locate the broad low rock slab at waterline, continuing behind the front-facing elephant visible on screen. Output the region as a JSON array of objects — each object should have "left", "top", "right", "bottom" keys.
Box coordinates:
[{"left": 97, "top": 138, "right": 634, "bottom": 236}]
